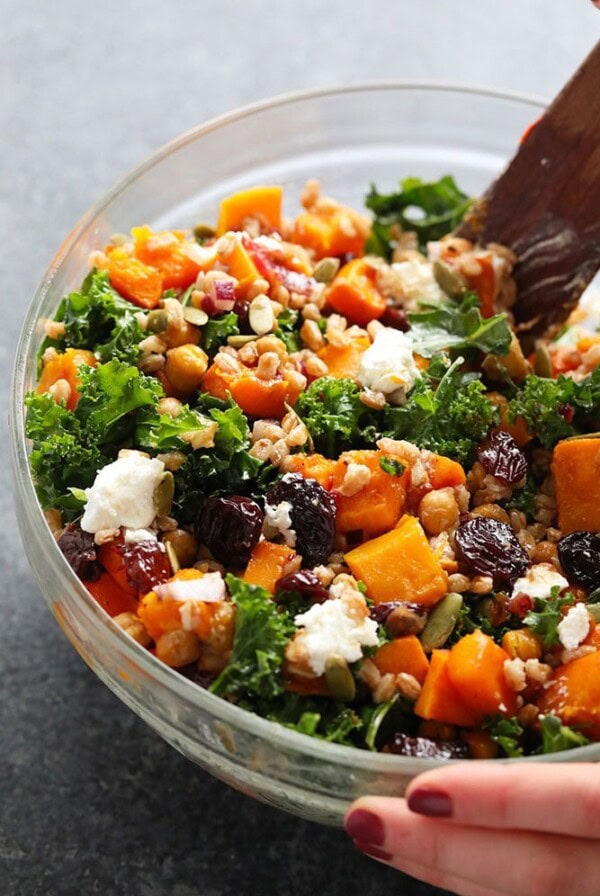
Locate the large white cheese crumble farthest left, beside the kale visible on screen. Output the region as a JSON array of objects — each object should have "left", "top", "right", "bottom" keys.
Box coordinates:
[{"left": 81, "top": 451, "right": 165, "bottom": 533}]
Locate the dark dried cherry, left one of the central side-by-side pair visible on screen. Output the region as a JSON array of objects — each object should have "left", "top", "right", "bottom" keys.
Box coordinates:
[{"left": 196, "top": 495, "right": 264, "bottom": 569}]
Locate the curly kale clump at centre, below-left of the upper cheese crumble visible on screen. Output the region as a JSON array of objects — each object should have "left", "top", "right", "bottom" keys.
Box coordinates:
[{"left": 294, "top": 376, "right": 377, "bottom": 458}]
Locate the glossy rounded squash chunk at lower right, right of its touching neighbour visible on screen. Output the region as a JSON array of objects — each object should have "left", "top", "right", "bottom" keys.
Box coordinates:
[{"left": 448, "top": 630, "right": 517, "bottom": 721}]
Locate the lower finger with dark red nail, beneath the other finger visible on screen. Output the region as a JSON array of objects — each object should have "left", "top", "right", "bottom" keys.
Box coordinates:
[{"left": 346, "top": 797, "right": 600, "bottom": 896}]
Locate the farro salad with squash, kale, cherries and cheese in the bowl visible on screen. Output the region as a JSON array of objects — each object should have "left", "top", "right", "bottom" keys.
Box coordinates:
[{"left": 26, "top": 176, "right": 600, "bottom": 758}]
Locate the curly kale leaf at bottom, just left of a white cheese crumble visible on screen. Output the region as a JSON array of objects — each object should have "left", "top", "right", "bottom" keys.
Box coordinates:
[{"left": 210, "top": 574, "right": 295, "bottom": 700}]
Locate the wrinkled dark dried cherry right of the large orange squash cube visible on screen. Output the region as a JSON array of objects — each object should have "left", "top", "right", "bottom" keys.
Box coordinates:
[{"left": 455, "top": 516, "right": 530, "bottom": 587}]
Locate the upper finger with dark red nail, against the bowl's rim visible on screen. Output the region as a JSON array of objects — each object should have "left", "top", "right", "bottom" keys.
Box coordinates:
[{"left": 406, "top": 763, "right": 600, "bottom": 839}]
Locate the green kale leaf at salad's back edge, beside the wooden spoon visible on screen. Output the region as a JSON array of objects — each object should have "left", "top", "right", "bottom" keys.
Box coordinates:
[{"left": 365, "top": 175, "right": 472, "bottom": 259}]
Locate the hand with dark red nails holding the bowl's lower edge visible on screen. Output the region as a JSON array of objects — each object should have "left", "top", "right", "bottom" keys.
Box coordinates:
[{"left": 345, "top": 762, "right": 600, "bottom": 896}]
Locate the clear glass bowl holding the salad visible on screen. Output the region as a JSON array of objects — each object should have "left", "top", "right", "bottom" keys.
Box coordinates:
[{"left": 11, "top": 84, "right": 600, "bottom": 825}]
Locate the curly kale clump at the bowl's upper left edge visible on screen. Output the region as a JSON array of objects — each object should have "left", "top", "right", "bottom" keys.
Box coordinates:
[{"left": 40, "top": 270, "right": 144, "bottom": 364}]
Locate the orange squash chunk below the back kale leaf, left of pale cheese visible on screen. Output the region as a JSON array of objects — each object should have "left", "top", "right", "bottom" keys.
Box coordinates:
[{"left": 327, "top": 258, "right": 386, "bottom": 327}]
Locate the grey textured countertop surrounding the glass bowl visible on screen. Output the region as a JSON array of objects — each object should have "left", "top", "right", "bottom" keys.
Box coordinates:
[{"left": 0, "top": 0, "right": 600, "bottom": 896}]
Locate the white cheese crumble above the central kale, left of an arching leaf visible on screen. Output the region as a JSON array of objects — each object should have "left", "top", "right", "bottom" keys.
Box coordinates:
[{"left": 358, "top": 327, "right": 420, "bottom": 395}]
